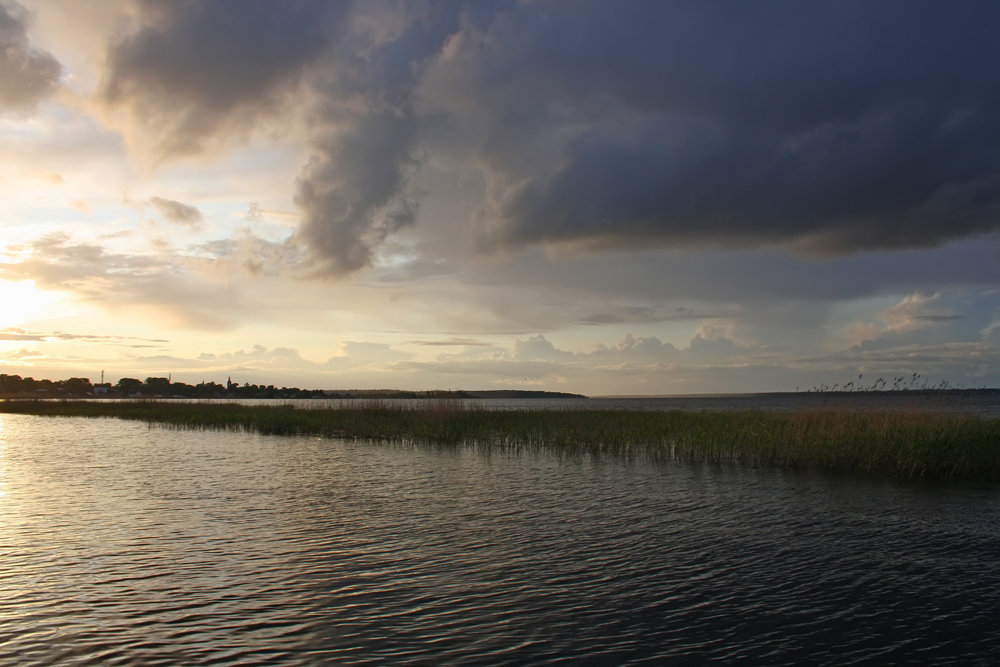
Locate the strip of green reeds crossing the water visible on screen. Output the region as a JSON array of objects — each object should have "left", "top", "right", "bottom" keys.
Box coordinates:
[{"left": 0, "top": 401, "right": 1000, "bottom": 482}]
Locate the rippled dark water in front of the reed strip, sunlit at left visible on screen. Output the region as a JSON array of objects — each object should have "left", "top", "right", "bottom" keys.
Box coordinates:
[{"left": 0, "top": 414, "right": 1000, "bottom": 665}]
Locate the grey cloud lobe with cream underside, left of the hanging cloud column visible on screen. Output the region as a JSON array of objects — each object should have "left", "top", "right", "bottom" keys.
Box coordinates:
[{"left": 98, "top": 0, "right": 347, "bottom": 157}]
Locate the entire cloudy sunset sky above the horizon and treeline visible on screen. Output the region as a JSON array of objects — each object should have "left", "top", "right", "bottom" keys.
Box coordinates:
[{"left": 0, "top": 0, "right": 1000, "bottom": 395}]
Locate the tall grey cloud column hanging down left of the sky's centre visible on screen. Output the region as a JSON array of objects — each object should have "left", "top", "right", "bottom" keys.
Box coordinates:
[{"left": 295, "top": 2, "right": 457, "bottom": 276}]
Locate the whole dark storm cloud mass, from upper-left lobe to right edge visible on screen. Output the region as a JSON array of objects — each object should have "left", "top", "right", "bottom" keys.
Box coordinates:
[{"left": 92, "top": 0, "right": 1000, "bottom": 276}]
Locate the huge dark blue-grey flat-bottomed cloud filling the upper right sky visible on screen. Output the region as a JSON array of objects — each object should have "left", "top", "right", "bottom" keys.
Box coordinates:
[{"left": 427, "top": 2, "right": 1000, "bottom": 253}]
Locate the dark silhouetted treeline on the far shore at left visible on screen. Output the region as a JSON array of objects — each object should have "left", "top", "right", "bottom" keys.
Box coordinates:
[{"left": 0, "top": 374, "right": 586, "bottom": 399}]
